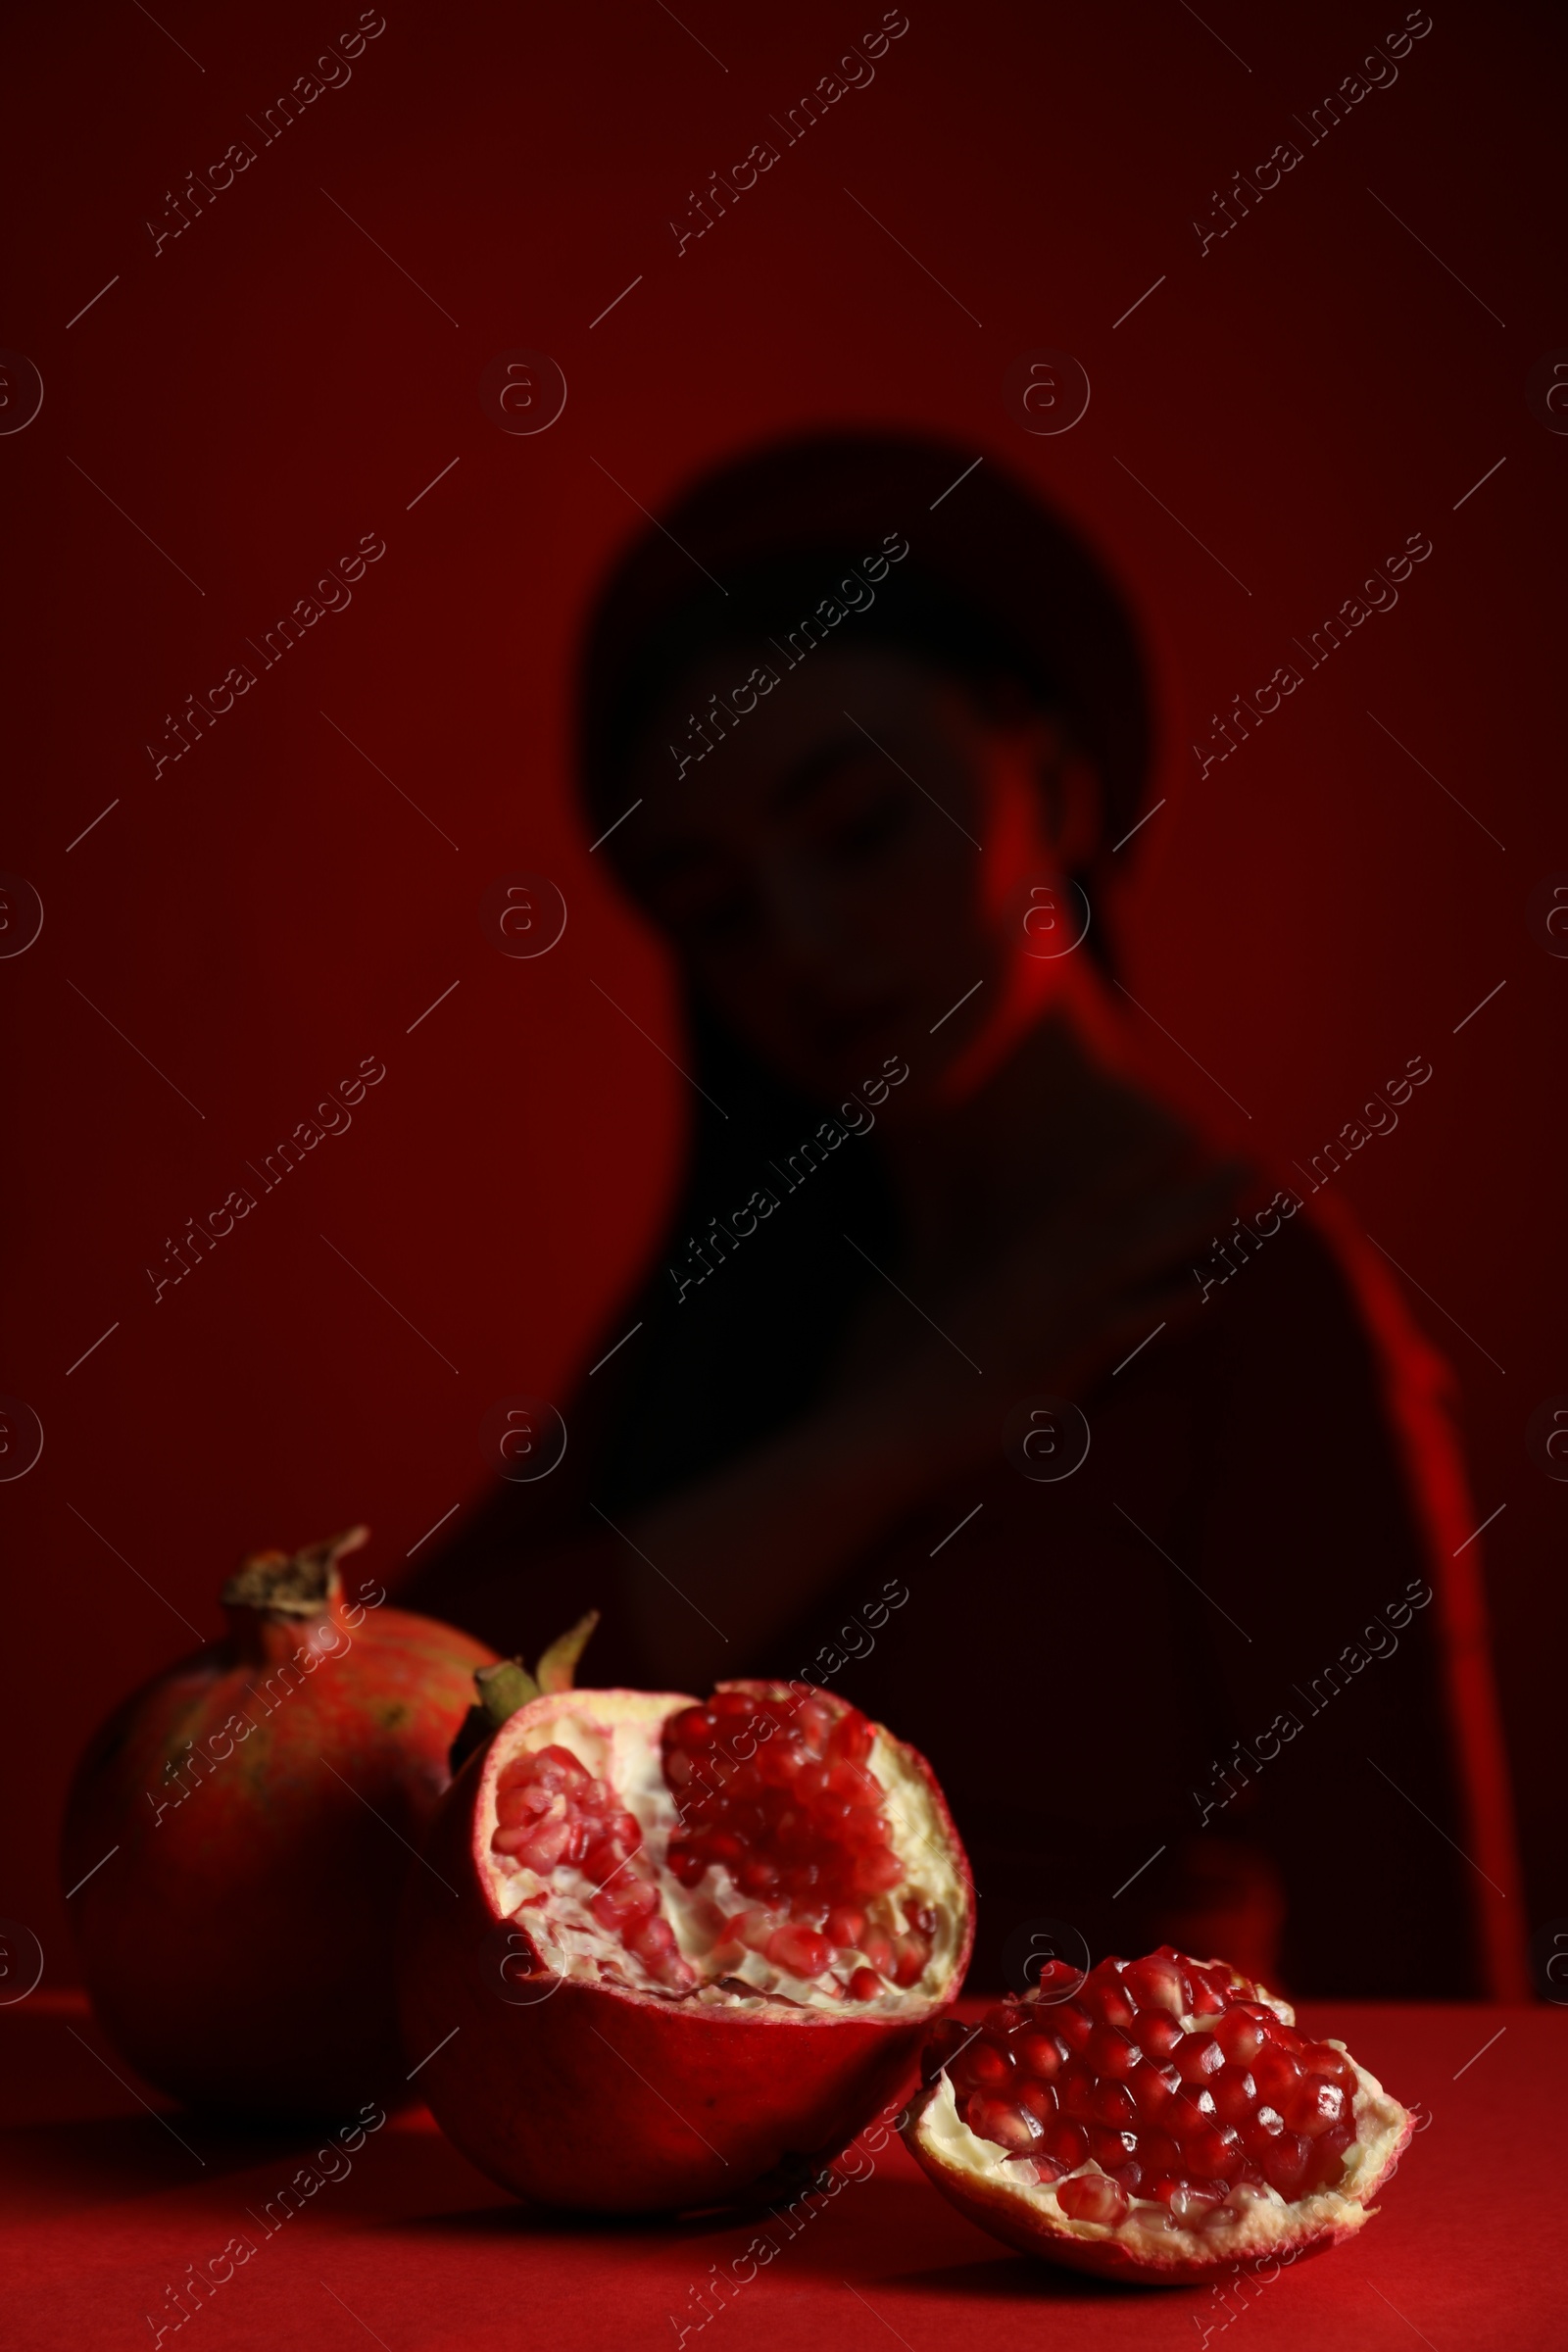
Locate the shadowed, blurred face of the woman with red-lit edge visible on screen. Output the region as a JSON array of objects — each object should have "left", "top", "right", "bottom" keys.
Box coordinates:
[{"left": 615, "top": 647, "right": 1093, "bottom": 1110}]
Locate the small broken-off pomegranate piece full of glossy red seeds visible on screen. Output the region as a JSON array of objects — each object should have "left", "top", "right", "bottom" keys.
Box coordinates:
[{"left": 906, "top": 1945, "right": 1413, "bottom": 2286}]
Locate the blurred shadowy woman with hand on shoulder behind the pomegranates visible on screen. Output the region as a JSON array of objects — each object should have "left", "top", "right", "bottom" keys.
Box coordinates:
[{"left": 412, "top": 435, "right": 1523, "bottom": 1997}]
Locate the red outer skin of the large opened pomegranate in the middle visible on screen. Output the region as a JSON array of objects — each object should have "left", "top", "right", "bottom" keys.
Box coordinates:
[{"left": 397, "top": 1682, "right": 973, "bottom": 2213}]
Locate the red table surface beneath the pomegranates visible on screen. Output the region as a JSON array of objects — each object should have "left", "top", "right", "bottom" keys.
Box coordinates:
[{"left": 0, "top": 1994, "right": 1568, "bottom": 2352}]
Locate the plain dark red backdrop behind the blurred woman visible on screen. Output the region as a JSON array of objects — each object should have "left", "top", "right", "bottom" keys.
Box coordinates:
[{"left": 0, "top": 0, "right": 1568, "bottom": 1981}]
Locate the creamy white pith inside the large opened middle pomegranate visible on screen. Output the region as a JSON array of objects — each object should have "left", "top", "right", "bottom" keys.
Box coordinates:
[{"left": 475, "top": 1691, "right": 980, "bottom": 2023}]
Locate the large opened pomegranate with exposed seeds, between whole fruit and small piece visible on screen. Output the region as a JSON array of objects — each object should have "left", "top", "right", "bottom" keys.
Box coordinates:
[{"left": 400, "top": 1665, "right": 973, "bottom": 2213}]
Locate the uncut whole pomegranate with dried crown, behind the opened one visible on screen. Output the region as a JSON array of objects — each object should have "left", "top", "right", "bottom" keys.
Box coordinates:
[{"left": 61, "top": 1527, "right": 494, "bottom": 2115}]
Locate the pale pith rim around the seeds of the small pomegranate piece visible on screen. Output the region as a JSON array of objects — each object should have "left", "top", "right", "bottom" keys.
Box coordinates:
[{"left": 917, "top": 1962, "right": 1408, "bottom": 2268}]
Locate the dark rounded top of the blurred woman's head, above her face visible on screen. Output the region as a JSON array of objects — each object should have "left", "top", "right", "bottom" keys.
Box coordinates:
[{"left": 581, "top": 433, "right": 1152, "bottom": 863}]
